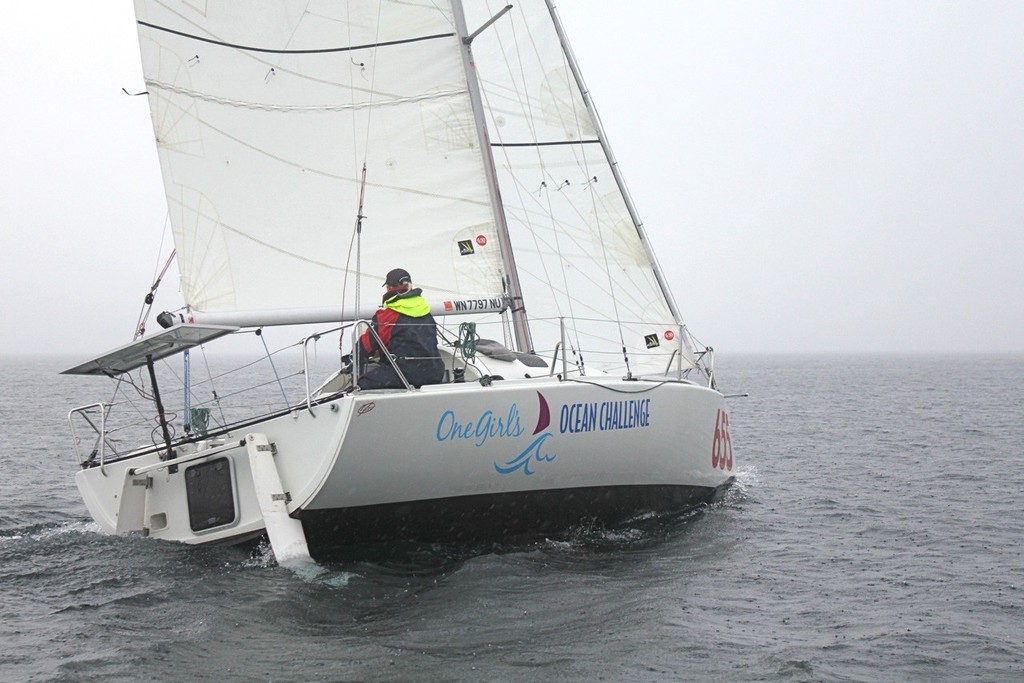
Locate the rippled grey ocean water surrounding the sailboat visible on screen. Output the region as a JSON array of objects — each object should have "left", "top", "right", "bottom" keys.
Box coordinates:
[{"left": 0, "top": 354, "right": 1024, "bottom": 681}]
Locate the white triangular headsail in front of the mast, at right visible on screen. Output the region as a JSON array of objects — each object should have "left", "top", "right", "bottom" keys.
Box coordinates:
[{"left": 466, "top": 0, "right": 692, "bottom": 372}]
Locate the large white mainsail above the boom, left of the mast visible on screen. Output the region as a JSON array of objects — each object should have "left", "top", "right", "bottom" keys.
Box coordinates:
[{"left": 135, "top": 0, "right": 503, "bottom": 317}]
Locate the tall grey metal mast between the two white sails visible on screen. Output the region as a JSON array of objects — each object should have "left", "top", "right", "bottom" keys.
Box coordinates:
[{"left": 452, "top": 0, "right": 536, "bottom": 351}]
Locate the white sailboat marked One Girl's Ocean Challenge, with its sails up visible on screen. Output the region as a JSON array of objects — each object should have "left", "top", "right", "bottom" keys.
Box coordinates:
[{"left": 65, "top": 0, "right": 736, "bottom": 564}]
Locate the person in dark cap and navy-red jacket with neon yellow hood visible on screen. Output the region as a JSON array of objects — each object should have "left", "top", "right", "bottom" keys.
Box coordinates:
[{"left": 358, "top": 268, "right": 444, "bottom": 389}]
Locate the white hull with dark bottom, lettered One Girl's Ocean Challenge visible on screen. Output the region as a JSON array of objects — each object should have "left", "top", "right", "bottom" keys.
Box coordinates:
[{"left": 77, "top": 377, "right": 735, "bottom": 552}]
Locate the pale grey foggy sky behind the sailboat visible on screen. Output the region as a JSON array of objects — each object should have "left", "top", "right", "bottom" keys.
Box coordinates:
[{"left": 0, "top": 0, "right": 1024, "bottom": 358}]
